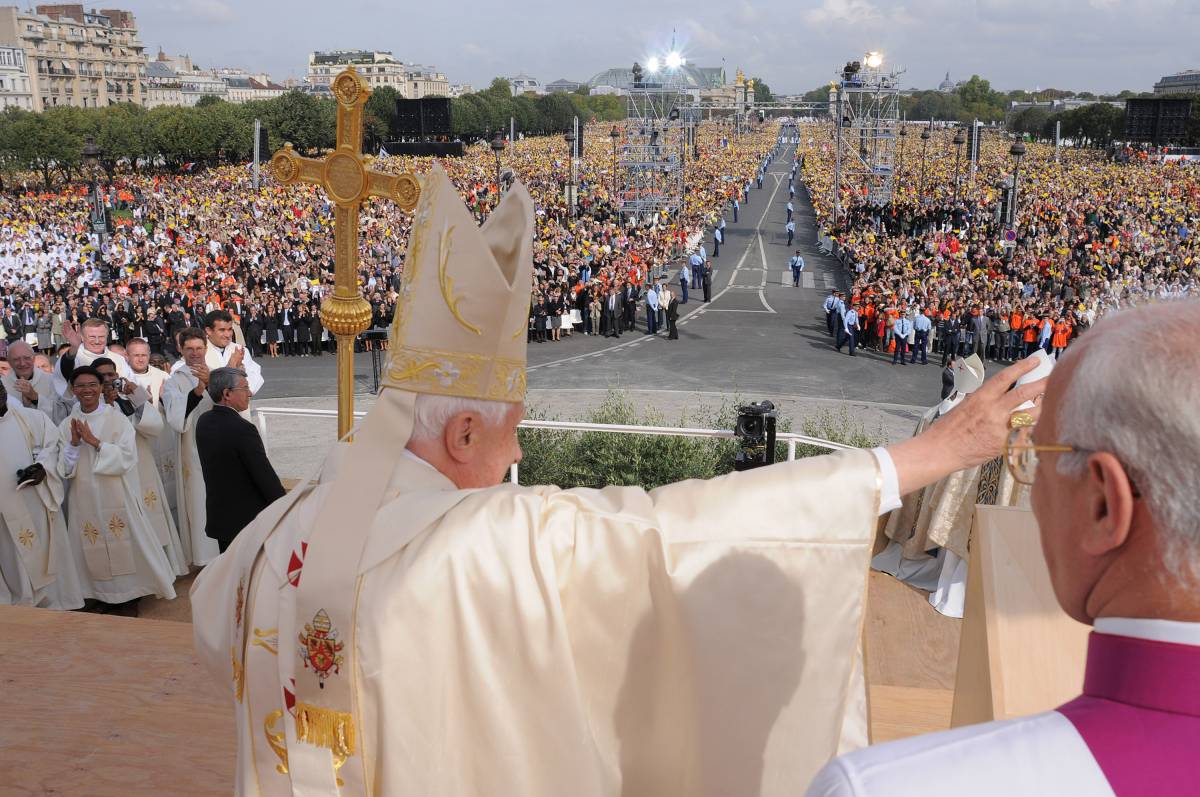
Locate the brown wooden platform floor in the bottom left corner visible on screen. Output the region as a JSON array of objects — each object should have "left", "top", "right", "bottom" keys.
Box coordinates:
[{"left": 0, "top": 606, "right": 236, "bottom": 797}]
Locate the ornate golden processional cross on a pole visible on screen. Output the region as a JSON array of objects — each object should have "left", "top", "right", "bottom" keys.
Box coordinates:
[{"left": 271, "top": 68, "right": 421, "bottom": 438}]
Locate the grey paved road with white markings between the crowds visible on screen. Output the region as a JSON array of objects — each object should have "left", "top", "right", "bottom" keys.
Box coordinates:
[{"left": 253, "top": 151, "right": 941, "bottom": 406}]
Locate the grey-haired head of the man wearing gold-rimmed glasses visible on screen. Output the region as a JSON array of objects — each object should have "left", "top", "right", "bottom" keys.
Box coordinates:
[{"left": 1032, "top": 301, "right": 1200, "bottom": 622}]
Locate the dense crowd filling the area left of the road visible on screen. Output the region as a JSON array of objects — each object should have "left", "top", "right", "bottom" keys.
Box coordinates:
[{"left": 0, "top": 124, "right": 775, "bottom": 358}]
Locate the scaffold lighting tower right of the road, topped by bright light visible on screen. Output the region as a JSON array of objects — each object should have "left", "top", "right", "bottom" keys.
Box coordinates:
[{"left": 830, "top": 52, "right": 904, "bottom": 220}]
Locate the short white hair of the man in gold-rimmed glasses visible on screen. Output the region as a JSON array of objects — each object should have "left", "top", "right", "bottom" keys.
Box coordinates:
[{"left": 1051, "top": 300, "right": 1200, "bottom": 583}]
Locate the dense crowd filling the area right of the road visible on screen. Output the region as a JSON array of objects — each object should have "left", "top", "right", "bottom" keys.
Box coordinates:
[{"left": 797, "top": 124, "right": 1200, "bottom": 361}]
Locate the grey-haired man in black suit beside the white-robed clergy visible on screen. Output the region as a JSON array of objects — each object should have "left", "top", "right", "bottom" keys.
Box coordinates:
[{"left": 196, "top": 368, "right": 283, "bottom": 552}]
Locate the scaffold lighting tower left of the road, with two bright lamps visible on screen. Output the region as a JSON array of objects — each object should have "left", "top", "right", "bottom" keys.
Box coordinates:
[{"left": 616, "top": 50, "right": 700, "bottom": 221}]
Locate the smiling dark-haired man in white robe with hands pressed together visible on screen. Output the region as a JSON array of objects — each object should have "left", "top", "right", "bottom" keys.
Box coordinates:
[{"left": 58, "top": 366, "right": 175, "bottom": 604}]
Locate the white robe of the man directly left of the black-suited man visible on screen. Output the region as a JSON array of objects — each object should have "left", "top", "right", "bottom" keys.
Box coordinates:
[{"left": 162, "top": 367, "right": 221, "bottom": 567}]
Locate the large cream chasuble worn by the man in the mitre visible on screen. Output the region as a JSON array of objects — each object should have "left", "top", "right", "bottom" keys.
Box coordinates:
[{"left": 192, "top": 447, "right": 880, "bottom": 797}]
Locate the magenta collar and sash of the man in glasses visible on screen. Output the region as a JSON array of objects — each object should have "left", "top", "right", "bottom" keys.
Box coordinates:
[{"left": 1058, "top": 631, "right": 1200, "bottom": 797}]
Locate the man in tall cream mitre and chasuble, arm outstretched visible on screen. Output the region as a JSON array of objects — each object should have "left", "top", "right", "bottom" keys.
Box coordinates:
[{"left": 192, "top": 167, "right": 1051, "bottom": 796}]
